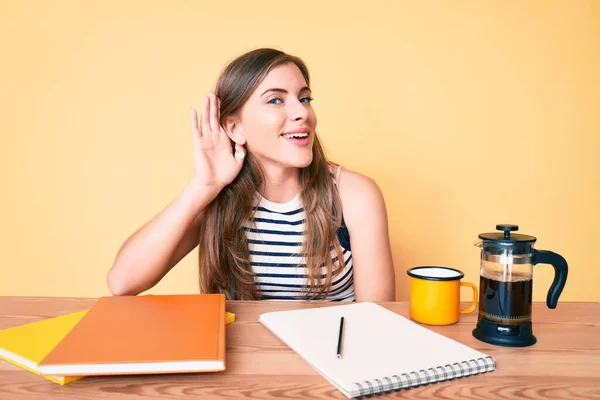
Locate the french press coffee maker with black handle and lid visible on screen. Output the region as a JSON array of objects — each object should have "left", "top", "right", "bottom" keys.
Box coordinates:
[{"left": 473, "top": 225, "right": 568, "bottom": 347}]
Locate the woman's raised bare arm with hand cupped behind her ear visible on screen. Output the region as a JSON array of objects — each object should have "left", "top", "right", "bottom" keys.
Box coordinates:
[{"left": 107, "top": 93, "right": 246, "bottom": 295}]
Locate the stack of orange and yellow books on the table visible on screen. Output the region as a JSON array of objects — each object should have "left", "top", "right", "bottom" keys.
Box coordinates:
[{"left": 0, "top": 294, "right": 235, "bottom": 385}]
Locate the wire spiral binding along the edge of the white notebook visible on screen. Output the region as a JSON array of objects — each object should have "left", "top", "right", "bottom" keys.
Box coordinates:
[{"left": 355, "top": 356, "right": 496, "bottom": 397}]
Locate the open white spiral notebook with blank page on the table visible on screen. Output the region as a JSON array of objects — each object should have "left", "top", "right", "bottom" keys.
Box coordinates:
[{"left": 259, "top": 302, "right": 496, "bottom": 398}]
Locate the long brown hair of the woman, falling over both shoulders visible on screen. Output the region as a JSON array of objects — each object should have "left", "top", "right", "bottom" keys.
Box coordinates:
[{"left": 199, "top": 48, "right": 344, "bottom": 300}]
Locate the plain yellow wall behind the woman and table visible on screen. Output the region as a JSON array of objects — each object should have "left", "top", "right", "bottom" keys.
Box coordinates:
[{"left": 0, "top": 0, "right": 600, "bottom": 301}]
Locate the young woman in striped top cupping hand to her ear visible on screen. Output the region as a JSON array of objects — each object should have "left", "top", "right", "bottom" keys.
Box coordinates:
[{"left": 107, "top": 49, "right": 395, "bottom": 301}]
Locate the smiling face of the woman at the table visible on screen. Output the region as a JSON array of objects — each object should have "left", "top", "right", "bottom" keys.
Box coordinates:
[{"left": 237, "top": 63, "right": 317, "bottom": 168}]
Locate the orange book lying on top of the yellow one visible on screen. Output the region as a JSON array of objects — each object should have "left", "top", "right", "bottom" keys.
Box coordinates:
[{"left": 38, "top": 294, "right": 225, "bottom": 376}]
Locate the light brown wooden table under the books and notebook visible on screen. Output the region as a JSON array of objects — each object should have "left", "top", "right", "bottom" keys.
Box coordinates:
[{"left": 0, "top": 297, "right": 600, "bottom": 400}]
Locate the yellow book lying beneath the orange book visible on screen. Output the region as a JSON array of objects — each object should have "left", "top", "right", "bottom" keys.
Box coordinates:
[{"left": 0, "top": 310, "right": 235, "bottom": 385}]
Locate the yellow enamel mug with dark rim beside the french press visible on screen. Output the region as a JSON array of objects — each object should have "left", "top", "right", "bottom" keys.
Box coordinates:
[{"left": 407, "top": 266, "right": 479, "bottom": 325}]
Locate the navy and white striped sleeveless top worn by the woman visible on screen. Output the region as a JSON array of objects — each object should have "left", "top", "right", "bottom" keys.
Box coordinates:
[{"left": 244, "top": 169, "right": 355, "bottom": 301}]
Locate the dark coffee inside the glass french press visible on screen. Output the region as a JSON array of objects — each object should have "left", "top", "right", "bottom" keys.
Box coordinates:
[{"left": 479, "top": 273, "right": 533, "bottom": 325}]
